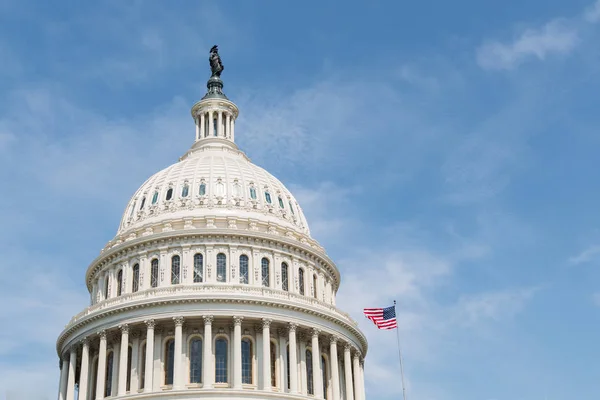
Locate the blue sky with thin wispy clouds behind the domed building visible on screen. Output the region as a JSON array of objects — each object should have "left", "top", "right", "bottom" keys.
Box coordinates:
[{"left": 0, "top": 0, "right": 600, "bottom": 400}]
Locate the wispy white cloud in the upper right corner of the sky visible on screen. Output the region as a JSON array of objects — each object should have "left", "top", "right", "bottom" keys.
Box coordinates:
[{"left": 477, "top": 19, "right": 578, "bottom": 70}]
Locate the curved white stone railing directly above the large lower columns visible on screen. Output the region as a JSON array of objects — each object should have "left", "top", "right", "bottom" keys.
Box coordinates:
[{"left": 67, "top": 283, "right": 358, "bottom": 327}]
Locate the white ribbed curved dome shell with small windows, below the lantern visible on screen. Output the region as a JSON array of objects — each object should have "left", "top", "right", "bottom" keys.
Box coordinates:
[{"left": 118, "top": 146, "right": 310, "bottom": 235}]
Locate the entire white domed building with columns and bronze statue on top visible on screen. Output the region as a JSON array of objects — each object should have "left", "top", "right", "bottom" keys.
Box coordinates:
[{"left": 57, "top": 46, "right": 367, "bottom": 400}]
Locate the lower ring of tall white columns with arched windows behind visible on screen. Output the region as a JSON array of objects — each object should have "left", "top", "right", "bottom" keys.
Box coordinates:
[{"left": 58, "top": 315, "right": 365, "bottom": 400}]
